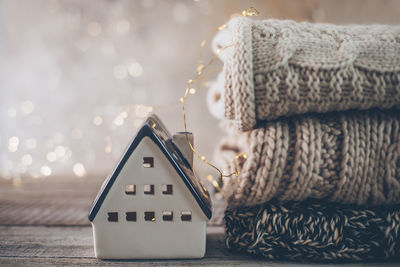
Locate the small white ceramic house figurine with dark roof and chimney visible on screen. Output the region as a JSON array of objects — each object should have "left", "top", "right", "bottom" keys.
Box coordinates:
[{"left": 89, "top": 115, "right": 211, "bottom": 259}]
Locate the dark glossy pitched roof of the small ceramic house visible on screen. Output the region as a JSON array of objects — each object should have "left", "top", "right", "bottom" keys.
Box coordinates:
[{"left": 89, "top": 114, "right": 212, "bottom": 221}]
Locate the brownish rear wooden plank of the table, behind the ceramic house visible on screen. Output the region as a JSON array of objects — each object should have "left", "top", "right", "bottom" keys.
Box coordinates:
[{"left": 0, "top": 176, "right": 225, "bottom": 226}]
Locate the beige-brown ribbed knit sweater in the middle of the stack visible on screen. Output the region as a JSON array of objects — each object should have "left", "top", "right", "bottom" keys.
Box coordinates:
[{"left": 216, "top": 109, "right": 400, "bottom": 206}]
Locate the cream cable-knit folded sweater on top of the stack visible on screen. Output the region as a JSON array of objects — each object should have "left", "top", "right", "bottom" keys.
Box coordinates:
[{"left": 213, "top": 18, "right": 400, "bottom": 130}]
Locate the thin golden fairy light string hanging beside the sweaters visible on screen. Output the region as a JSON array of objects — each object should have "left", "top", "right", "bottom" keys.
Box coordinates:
[{"left": 180, "top": 7, "right": 259, "bottom": 193}]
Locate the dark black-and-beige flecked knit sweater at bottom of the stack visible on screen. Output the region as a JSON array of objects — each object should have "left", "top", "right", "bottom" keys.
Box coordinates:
[{"left": 225, "top": 201, "right": 400, "bottom": 261}]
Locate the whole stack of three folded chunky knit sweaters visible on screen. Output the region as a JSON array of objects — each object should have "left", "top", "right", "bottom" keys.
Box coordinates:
[{"left": 208, "top": 18, "right": 400, "bottom": 261}]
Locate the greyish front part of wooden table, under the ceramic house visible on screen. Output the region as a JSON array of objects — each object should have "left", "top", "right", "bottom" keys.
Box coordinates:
[{"left": 0, "top": 226, "right": 399, "bottom": 266}]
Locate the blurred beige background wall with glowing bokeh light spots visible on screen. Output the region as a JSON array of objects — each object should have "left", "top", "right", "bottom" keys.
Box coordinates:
[{"left": 0, "top": 0, "right": 400, "bottom": 185}]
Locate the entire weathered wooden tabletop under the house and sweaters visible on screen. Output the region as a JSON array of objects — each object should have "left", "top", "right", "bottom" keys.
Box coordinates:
[{"left": 0, "top": 178, "right": 400, "bottom": 266}]
